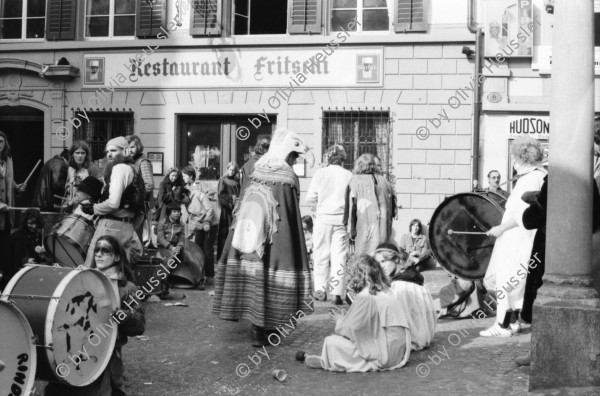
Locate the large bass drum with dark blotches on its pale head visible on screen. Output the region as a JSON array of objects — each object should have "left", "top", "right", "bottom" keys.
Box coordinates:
[{"left": 0, "top": 265, "right": 119, "bottom": 386}]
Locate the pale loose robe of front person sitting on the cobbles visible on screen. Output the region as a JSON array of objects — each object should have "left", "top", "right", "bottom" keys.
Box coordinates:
[{"left": 321, "top": 288, "right": 411, "bottom": 372}]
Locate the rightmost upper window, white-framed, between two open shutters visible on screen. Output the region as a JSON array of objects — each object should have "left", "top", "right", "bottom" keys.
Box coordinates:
[{"left": 331, "top": 0, "right": 391, "bottom": 32}]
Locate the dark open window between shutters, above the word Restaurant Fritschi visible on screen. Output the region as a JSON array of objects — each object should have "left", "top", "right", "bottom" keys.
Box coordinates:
[{"left": 231, "top": 0, "right": 287, "bottom": 35}]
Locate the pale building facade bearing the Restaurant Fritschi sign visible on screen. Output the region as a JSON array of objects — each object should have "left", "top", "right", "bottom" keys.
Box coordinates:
[{"left": 0, "top": 0, "right": 478, "bottom": 239}]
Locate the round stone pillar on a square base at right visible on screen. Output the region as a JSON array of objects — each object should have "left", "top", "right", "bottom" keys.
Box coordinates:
[{"left": 529, "top": 0, "right": 600, "bottom": 390}]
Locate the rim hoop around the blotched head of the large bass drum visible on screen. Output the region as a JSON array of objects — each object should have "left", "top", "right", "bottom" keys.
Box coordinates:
[{"left": 44, "top": 267, "right": 120, "bottom": 387}]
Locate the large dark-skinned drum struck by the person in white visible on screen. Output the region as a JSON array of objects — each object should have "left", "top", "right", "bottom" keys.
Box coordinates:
[{"left": 429, "top": 192, "right": 506, "bottom": 280}]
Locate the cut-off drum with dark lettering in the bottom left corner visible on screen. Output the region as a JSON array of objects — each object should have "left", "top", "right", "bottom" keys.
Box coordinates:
[{"left": 0, "top": 301, "right": 37, "bottom": 395}]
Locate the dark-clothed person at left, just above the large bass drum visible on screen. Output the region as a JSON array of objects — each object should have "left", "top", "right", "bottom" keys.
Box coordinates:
[{"left": 2, "top": 208, "right": 46, "bottom": 283}]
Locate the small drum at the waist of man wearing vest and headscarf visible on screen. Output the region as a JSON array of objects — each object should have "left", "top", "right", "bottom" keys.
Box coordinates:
[{"left": 44, "top": 215, "right": 96, "bottom": 267}]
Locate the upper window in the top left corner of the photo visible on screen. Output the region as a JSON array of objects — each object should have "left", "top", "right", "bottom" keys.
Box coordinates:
[{"left": 0, "top": 0, "right": 46, "bottom": 39}]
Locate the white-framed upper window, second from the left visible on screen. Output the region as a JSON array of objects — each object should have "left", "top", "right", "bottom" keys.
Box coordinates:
[{"left": 85, "top": 0, "right": 135, "bottom": 37}]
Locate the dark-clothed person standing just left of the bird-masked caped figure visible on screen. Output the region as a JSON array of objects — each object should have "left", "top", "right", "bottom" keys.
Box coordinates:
[{"left": 217, "top": 162, "right": 240, "bottom": 259}]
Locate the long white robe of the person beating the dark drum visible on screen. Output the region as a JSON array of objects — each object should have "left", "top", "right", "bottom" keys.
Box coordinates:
[{"left": 484, "top": 168, "right": 546, "bottom": 321}]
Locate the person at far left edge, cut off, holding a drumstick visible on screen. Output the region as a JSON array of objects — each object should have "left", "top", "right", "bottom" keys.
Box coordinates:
[{"left": 0, "top": 131, "right": 27, "bottom": 289}]
